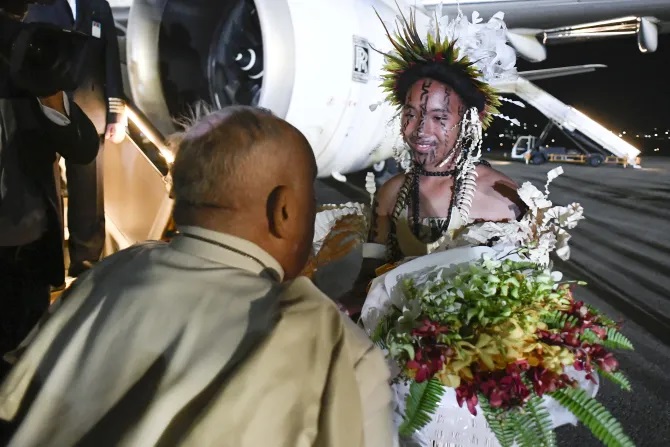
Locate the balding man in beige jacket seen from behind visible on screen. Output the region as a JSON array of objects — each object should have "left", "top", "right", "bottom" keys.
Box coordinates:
[{"left": 0, "top": 107, "right": 397, "bottom": 447}]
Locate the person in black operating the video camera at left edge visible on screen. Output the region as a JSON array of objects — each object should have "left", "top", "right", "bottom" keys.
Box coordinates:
[{"left": 0, "top": 7, "right": 99, "bottom": 377}]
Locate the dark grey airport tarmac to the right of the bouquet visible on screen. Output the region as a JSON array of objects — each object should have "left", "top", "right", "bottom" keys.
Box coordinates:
[{"left": 317, "top": 157, "right": 670, "bottom": 447}]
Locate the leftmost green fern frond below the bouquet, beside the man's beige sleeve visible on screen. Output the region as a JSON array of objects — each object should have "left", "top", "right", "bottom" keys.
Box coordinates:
[{"left": 398, "top": 379, "right": 445, "bottom": 436}]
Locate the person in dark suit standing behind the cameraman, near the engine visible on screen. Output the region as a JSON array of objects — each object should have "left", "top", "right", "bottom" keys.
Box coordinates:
[{"left": 25, "top": 0, "right": 126, "bottom": 276}]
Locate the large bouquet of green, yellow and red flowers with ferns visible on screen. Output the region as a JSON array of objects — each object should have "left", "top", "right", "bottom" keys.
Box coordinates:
[{"left": 372, "top": 168, "right": 633, "bottom": 447}]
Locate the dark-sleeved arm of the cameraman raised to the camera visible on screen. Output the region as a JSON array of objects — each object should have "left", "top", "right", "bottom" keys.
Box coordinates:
[{"left": 39, "top": 92, "right": 100, "bottom": 164}]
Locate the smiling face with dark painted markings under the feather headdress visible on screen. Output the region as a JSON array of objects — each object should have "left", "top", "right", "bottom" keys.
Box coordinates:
[{"left": 401, "top": 79, "right": 466, "bottom": 169}]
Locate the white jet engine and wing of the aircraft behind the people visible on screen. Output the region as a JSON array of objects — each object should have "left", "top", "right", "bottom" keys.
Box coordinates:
[{"left": 118, "top": 0, "right": 670, "bottom": 177}]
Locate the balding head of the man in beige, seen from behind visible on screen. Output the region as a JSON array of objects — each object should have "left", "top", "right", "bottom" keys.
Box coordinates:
[{"left": 172, "top": 106, "right": 317, "bottom": 279}]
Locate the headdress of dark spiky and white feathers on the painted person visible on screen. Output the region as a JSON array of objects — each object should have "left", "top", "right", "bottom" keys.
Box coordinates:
[{"left": 377, "top": 6, "right": 516, "bottom": 128}]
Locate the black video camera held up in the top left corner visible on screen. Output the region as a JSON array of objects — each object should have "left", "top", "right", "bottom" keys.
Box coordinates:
[{"left": 0, "top": 0, "right": 93, "bottom": 98}]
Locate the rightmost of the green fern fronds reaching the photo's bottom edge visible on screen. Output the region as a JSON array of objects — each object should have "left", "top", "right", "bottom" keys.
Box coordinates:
[{"left": 550, "top": 388, "right": 635, "bottom": 447}]
